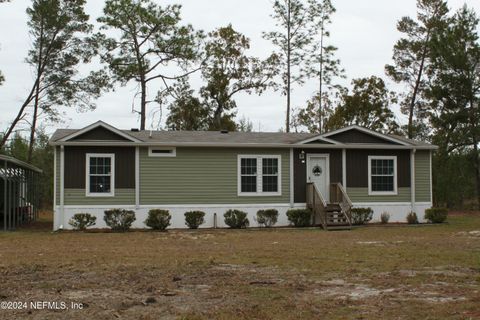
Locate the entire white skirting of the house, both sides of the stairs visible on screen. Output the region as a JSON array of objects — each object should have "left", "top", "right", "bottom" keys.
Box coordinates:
[{"left": 54, "top": 202, "right": 432, "bottom": 230}]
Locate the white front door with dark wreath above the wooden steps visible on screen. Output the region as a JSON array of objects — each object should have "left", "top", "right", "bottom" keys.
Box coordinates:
[{"left": 307, "top": 154, "right": 330, "bottom": 202}]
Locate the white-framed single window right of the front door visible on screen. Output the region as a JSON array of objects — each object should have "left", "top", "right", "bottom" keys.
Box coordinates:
[{"left": 368, "top": 156, "right": 397, "bottom": 195}]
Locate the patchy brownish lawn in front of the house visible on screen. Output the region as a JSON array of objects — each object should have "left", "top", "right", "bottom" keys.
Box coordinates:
[{"left": 0, "top": 215, "right": 480, "bottom": 319}]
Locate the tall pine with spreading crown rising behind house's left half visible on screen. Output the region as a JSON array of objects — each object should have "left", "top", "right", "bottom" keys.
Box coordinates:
[{"left": 98, "top": 0, "right": 202, "bottom": 130}]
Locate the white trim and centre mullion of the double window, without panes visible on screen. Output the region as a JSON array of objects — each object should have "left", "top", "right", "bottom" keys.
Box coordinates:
[{"left": 237, "top": 154, "right": 282, "bottom": 197}]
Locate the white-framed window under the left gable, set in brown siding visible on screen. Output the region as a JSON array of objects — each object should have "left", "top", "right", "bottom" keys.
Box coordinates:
[{"left": 86, "top": 153, "right": 115, "bottom": 197}]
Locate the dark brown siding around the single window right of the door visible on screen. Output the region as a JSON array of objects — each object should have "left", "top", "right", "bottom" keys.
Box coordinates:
[{"left": 347, "top": 149, "right": 410, "bottom": 188}]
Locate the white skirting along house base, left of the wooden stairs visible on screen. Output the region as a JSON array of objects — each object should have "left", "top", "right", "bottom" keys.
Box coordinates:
[{"left": 54, "top": 203, "right": 305, "bottom": 230}]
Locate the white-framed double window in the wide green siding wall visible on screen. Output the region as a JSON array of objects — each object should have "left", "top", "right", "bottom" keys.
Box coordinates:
[{"left": 238, "top": 155, "right": 281, "bottom": 196}]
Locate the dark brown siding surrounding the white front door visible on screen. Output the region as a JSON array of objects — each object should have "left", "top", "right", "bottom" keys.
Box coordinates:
[{"left": 293, "top": 149, "right": 342, "bottom": 203}]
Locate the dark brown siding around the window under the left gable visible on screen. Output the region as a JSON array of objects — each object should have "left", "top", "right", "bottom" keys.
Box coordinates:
[{"left": 65, "top": 146, "right": 135, "bottom": 189}]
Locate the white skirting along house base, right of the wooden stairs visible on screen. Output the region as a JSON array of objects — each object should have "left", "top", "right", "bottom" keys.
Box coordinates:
[{"left": 353, "top": 202, "right": 432, "bottom": 222}]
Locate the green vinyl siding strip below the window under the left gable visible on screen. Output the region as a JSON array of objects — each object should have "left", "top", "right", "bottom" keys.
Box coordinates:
[{"left": 65, "top": 189, "right": 135, "bottom": 206}]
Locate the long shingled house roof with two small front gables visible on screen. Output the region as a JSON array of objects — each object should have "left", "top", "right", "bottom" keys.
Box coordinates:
[{"left": 50, "top": 121, "right": 436, "bottom": 149}]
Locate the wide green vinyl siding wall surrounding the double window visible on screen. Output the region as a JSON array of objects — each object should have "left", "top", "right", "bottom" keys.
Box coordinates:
[{"left": 140, "top": 148, "right": 290, "bottom": 205}]
